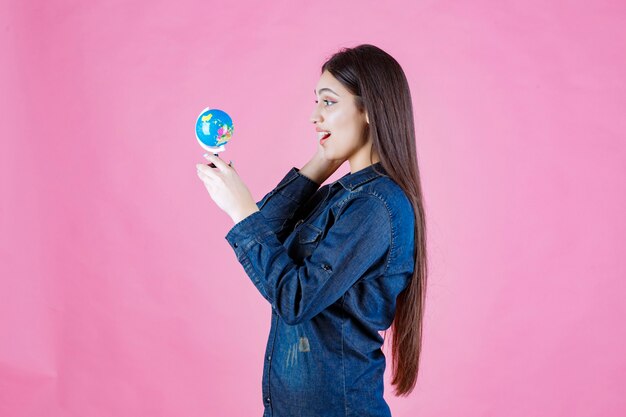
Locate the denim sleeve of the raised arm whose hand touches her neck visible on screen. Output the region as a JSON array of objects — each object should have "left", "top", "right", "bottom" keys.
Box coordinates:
[{"left": 256, "top": 167, "right": 320, "bottom": 242}]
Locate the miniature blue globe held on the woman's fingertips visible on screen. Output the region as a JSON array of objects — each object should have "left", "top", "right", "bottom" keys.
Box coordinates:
[{"left": 196, "top": 107, "right": 233, "bottom": 153}]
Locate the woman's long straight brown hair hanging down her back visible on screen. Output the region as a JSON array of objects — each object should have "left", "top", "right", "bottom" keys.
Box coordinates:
[{"left": 322, "top": 44, "right": 428, "bottom": 396}]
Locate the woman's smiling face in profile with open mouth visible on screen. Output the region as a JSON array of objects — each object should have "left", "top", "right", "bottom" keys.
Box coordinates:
[{"left": 311, "top": 71, "right": 371, "bottom": 163}]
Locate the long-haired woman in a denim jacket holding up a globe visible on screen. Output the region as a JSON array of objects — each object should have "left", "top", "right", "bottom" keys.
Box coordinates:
[{"left": 198, "top": 45, "right": 427, "bottom": 417}]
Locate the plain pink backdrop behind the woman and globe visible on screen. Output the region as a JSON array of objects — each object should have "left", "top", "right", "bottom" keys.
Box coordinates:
[{"left": 0, "top": 0, "right": 626, "bottom": 417}]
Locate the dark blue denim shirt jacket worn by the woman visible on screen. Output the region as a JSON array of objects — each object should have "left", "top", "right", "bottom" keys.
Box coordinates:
[{"left": 225, "top": 163, "right": 414, "bottom": 417}]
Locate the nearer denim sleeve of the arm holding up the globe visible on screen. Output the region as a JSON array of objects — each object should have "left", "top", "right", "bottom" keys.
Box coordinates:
[{"left": 226, "top": 195, "right": 392, "bottom": 324}]
